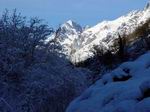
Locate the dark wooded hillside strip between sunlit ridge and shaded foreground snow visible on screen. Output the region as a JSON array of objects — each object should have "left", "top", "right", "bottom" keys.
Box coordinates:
[{"left": 76, "top": 19, "right": 150, "bottom": 82}]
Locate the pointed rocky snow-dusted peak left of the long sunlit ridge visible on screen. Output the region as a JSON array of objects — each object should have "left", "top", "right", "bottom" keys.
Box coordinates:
[{"left": 46, "top": 20, "right": 83, "bottom": 58}]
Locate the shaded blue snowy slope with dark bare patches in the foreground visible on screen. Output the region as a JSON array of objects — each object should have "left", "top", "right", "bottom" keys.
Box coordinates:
[{"left": 66, "top": 52, "right": 150, "bottom": 112}]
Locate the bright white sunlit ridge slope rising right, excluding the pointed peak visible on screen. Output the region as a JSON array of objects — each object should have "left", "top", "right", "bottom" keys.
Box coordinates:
[{"left": 72, "top": 3, "right": 150, "bottom": 61}]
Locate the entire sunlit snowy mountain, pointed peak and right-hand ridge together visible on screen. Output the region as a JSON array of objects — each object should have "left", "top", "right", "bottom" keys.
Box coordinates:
[{"left": 46, "top": 4, "right": 150, "bottom": 62}]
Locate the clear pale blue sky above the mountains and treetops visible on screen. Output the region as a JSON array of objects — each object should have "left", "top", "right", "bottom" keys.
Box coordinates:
[{"left": 0, "top": 0, "right": 149, "bottom": 27}]
